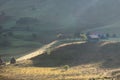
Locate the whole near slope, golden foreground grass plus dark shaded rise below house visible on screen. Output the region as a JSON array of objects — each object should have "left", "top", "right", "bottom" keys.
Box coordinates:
[{"left": 0, "top": 42, "right": 120, "bottom": 80}]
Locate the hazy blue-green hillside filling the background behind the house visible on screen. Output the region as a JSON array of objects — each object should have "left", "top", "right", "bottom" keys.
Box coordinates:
[{"left": 0, "top": 0, "right": 120, "bottom": 57}]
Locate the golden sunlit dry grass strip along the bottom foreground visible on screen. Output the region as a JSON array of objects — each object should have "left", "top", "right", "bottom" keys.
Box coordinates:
[{"left": 0, "top": 64, "right": 107, "bottom": 80}]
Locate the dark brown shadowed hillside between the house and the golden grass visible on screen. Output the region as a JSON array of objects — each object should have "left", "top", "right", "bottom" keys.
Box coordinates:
[{"left": 32, "top": 42, "right": 120, "bottom": 68}]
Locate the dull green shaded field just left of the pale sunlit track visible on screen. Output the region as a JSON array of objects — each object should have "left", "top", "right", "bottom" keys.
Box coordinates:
[{"left": 0, "top": 39, "right": 43, "bottom": 61}]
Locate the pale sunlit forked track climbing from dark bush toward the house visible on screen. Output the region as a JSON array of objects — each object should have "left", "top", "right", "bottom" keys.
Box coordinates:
[{"left": 17, "top": 40, "right": 85, "bottom": 61}]
